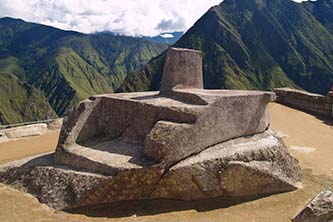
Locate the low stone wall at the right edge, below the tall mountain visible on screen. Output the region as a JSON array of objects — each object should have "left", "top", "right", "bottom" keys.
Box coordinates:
[{"left": 274, "top": 88, "right": 333, "bottom": 118}]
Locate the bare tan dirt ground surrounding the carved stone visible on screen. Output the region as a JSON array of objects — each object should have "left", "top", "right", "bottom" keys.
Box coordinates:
[{"left": 0, "top": 104, "right": 333, "bottom": 222}]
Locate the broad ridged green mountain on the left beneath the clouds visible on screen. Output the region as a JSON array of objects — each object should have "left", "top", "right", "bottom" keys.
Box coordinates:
[{"left": 0, "top": 18, "right": 167, "bottom": 116}]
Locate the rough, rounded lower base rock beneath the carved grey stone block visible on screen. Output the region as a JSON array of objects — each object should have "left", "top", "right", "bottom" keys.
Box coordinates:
[{"left": 0, "top": 131, "right": 302, "bottom": 210}]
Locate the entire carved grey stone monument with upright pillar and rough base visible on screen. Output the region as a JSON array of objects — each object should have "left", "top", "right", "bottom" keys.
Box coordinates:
[{"left": 0, "top": 48, "right": 302, "bottom": 209}]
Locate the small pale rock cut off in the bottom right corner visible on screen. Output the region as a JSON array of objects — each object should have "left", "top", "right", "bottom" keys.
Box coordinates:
[{"left": 292, "top": 190, "right": 333, "bottom": 222}]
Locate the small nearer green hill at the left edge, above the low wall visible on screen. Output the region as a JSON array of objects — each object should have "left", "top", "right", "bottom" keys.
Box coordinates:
[{"left": 0, "top": 73, "right": 57, "bottom": 124}]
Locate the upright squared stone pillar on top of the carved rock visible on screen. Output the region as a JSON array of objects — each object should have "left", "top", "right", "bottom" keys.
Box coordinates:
[{"left": 160, "top": 48, "right": 203, "bottom": 95}]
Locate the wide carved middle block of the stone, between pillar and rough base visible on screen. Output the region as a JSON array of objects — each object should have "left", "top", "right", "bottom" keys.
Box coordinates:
[{"left": 56, "top": 89, "right": 274, "bottom": 174}]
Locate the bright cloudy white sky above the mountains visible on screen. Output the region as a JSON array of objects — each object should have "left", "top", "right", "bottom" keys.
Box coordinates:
[{"left": 0, "top": 0, "right": 310, "bottom": 36}]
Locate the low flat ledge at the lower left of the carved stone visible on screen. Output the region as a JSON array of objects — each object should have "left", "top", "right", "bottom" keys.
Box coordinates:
[{"left": 55, "top": 139, "right": 152, "bottom": 176}]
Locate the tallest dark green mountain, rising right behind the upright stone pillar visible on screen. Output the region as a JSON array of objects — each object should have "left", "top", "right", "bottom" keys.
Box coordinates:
[{"left": 118, "top": 0, "right": 333, "bottom": 94}]
